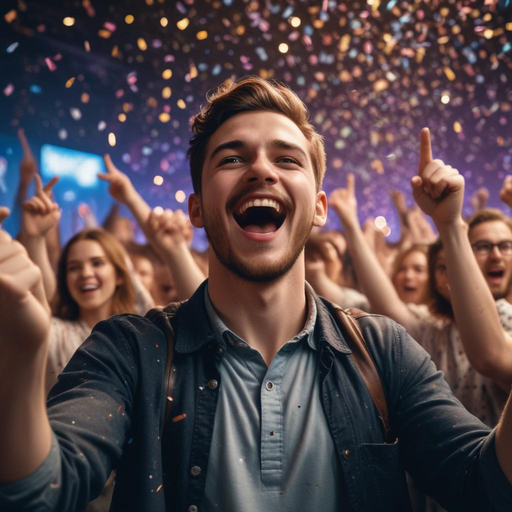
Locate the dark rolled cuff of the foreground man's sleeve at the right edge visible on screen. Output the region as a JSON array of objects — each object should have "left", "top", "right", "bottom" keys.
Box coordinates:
[{"left": 480, "top": 429, "right": 512, "bottom": 510}]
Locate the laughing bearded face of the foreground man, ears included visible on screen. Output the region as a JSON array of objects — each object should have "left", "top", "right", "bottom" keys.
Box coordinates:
[{"left": 189, "top": 111, "right": 327, "bottom": 282}]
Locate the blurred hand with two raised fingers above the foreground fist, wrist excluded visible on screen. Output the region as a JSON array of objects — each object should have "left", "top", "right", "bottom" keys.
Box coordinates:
[{"left": 21, "top": 174, "right": 61, "bottom": 237}]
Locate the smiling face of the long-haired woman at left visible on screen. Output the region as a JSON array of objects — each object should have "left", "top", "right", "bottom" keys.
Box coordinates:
[{"left": 66, "top": 240, "right": 122, "bottom": 318}]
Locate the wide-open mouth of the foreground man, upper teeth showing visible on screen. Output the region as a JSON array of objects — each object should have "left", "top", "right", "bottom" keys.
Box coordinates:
[{"left": 233, "top": 198, "right": 286, "bottom": 233}]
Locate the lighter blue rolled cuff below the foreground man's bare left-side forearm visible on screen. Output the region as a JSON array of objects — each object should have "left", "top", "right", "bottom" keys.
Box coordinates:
[{"left": 0, "top": 433, "right": 61, "bottom": 512}]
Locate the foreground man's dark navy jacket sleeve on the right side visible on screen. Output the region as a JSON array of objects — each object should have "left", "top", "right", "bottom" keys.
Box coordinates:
[{"left": 374, "top": 319, "right": 512, "bottom": 512}]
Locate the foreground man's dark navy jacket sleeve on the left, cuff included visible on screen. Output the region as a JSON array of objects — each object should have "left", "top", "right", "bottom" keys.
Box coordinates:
[{"left": 0, "top": 317, "right": 147, "bottom": 512}]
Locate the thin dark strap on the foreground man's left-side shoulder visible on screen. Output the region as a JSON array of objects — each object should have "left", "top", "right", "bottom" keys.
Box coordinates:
[{"left": 146, "top": 302, "right": 183, "bottom": 438}]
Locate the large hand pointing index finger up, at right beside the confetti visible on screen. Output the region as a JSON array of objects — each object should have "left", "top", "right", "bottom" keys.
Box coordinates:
[{"left": 411, "top": 128, "right": 464, "bottom": 227}]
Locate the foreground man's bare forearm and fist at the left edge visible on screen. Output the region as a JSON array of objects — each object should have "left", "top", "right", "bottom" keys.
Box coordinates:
[{"left": 0, "top": 208, "right": 51, "bottom": 484}]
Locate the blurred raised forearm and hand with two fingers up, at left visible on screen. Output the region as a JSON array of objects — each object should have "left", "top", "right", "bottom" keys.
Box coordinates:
[{"left": 19, "top": 174, "right": 61, "bottom": 301}]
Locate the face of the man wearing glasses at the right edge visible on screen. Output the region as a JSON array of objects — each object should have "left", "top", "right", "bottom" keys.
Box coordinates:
[{"left": 469, "top": 220, "right": 512, "bottom": 300}]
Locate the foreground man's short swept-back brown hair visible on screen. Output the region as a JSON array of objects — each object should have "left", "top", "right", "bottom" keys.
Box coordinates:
[{"left": 188, "top": 76, "right": 326, "bottom": 194}]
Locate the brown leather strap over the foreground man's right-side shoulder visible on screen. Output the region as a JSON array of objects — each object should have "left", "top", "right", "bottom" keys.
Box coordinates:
[{"left": 334, "top": 306, "right": 389, "bottom": 442}]
